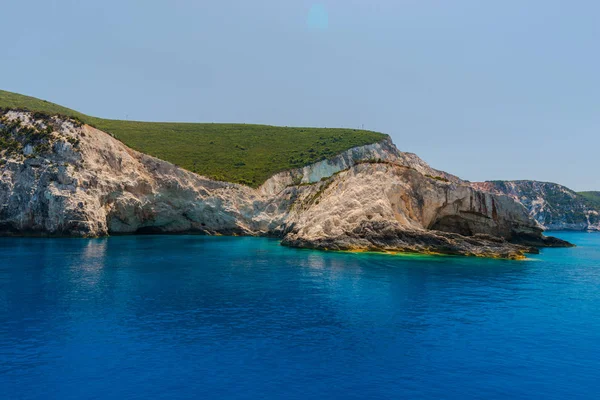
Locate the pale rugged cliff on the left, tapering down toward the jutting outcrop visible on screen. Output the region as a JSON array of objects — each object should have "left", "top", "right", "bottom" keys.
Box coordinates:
[{"left": 0, "top": 112, "right": 287, "bottom": 236}]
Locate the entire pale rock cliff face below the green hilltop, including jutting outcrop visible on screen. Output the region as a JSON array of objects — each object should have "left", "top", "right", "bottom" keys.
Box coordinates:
[{"left": 0, "top": 111, "right": 564, "bottom": 258}]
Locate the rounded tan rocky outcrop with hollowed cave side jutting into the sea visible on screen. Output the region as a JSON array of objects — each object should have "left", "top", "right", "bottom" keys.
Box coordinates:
[{"left": 283, "top": 163, "right": 566, "bottom": 258}]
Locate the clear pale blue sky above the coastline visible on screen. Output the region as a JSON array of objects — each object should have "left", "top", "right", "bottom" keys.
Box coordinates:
[{"left": 0, "top": 0, "right": 600, "bottom": 190}]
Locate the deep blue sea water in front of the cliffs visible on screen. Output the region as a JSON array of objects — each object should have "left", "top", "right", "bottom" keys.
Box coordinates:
[{"left": 0, "top": 233, "right": 600, "bottom": 399}]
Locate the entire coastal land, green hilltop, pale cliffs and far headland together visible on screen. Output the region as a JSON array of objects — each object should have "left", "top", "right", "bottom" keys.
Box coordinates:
[{"left": 0, "top": 91, "right": 584, "bottom": 259}]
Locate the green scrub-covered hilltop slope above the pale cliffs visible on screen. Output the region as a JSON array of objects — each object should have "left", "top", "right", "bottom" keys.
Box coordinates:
[{"left": 0, "top": 90, "right": 386, "bottom": 187}]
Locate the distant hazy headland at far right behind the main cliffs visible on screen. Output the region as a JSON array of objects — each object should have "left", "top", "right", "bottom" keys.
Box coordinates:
[{"left": 472, "top": 181, "right": 600, "bottom": 231}]
